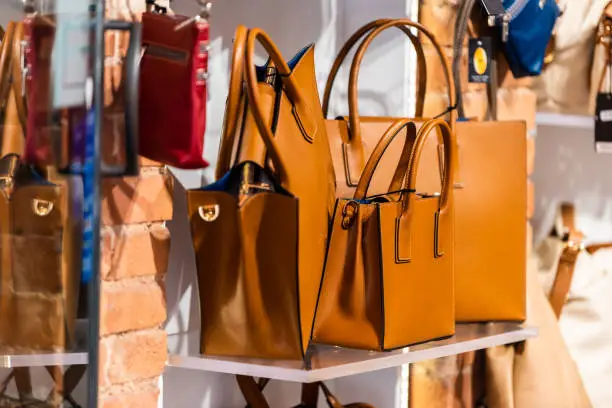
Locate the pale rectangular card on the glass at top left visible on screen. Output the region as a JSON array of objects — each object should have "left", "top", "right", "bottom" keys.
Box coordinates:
[{"left": 52, "top": 0, "right": 91, "bottom": 109}]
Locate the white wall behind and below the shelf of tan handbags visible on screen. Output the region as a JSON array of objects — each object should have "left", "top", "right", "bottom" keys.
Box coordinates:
[{"left": 164, "top": 0, "right": 414, "bottom": 408}]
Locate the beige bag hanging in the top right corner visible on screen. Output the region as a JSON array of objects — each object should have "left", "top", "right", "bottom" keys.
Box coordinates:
[{"left": 533, "top": 0, "right": 609, "bottom": 115}]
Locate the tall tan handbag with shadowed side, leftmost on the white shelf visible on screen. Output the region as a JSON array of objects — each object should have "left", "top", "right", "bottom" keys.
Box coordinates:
[{"left": 187, "top": 26, "right": 334, "bottom": 359}]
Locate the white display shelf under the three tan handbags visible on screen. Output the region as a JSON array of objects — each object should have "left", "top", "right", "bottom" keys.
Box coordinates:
[{"left": 168, "top": 323, "right": 538, "bottom": 383}]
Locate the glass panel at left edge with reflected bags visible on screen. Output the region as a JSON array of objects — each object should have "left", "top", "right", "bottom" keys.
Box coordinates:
[{"left": 0, "top": 0, "right": 98, "bottom": 407}]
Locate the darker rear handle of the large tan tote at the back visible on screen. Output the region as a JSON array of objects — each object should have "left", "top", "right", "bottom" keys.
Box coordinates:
[{"left": 322, "top": 18, "right": 427, "bottom": 117}]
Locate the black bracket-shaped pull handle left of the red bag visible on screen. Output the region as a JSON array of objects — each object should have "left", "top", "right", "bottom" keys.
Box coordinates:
[{"left": 100, "top": 20, "right": 142, "bottom": 177}]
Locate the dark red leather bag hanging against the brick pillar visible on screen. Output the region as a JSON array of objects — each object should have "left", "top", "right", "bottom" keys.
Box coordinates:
[{"left": 139, "top": 12, "right": 209, "bottom": 169}]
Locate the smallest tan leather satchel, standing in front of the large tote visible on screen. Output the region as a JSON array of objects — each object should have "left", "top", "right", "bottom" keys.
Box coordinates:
[{"left": 313, "top": 119, "right": 456, "bottom": 350}]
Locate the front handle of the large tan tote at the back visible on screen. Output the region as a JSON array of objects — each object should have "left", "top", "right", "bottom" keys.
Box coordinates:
[{"left": 349, "top": 18, "right": 456, "bottom": 145}]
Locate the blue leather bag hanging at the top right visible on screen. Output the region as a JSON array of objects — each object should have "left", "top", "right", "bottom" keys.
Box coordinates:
[{"left": 502, "top": 0, "right": 561, "bottom": 78}]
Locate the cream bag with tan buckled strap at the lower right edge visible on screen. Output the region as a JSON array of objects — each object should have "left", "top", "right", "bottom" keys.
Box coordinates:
[{"left": 535, "top": 203, "right": 612, "bottom": 407}]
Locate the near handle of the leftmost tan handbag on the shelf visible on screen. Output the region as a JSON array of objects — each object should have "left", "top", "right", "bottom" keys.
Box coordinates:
[{"left": 244, "top": 28, "right": 317, "bottom": 185}]
